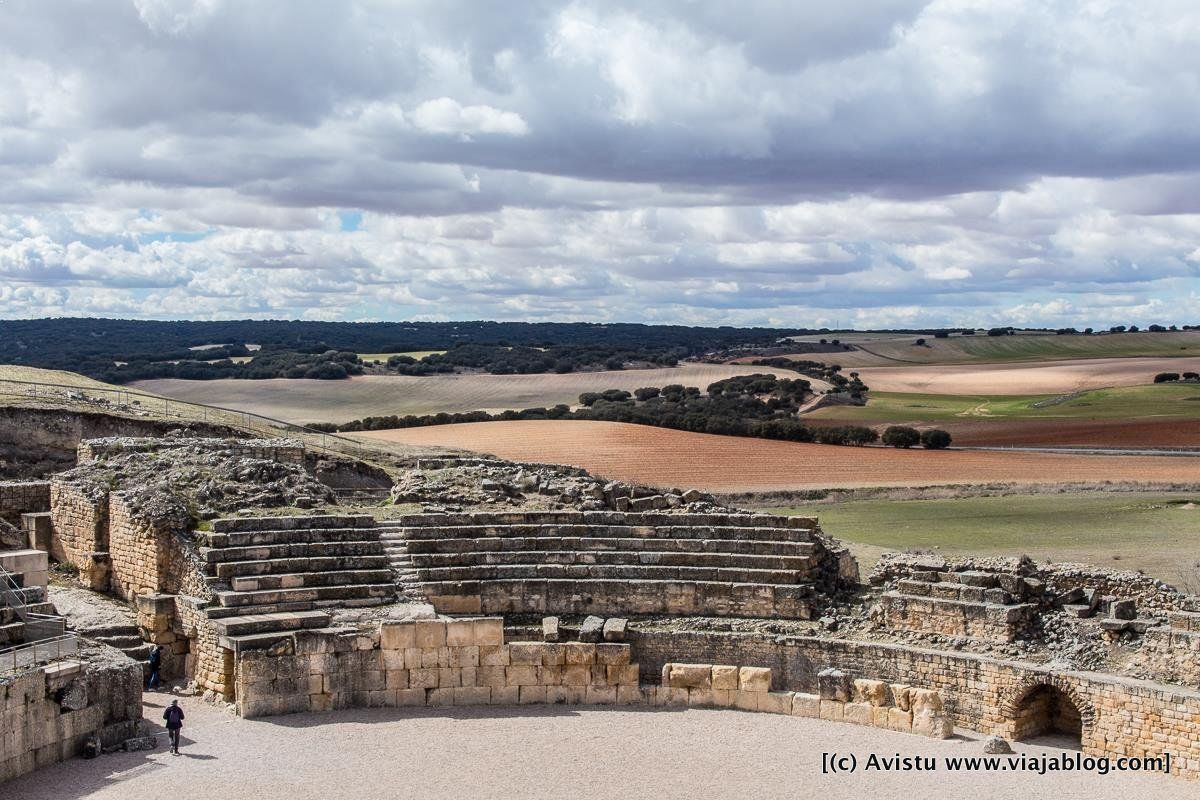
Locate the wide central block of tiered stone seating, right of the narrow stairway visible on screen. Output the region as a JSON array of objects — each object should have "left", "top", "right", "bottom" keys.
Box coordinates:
[{"left": 384, "top": 512, "right": 835, "bottom": 619}]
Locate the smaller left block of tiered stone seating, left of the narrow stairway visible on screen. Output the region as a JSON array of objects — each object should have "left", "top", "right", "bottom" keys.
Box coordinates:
[{"left": 199, "top": 516, "right": 396, "bottom": 649}]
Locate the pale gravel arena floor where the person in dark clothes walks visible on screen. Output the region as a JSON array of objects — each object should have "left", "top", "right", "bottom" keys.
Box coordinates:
[{"left": 7, "top": 694, "right": 1196, "bottom": 800}]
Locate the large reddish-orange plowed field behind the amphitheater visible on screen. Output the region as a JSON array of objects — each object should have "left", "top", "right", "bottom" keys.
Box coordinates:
[{"left": 356, "top": 420, "right": 1200, "bottom": 492}]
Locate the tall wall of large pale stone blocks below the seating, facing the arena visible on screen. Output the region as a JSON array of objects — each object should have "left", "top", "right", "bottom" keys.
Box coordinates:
[{"left": 236, "top": 619, "right": 643, "bottom": 717}]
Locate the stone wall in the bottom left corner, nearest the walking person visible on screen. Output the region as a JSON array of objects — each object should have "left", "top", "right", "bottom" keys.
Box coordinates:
[{"left": 0, "top": 660, "right": 142, "bottom": 783}]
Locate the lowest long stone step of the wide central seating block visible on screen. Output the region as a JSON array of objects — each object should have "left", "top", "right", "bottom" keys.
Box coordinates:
[{"left": 418, "top": 564, "right": 811, "bottom": 584}]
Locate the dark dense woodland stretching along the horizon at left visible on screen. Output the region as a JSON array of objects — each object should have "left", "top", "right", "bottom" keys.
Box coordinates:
[{"left": 0, "top": 318, "right": 816, "bottom": 383}]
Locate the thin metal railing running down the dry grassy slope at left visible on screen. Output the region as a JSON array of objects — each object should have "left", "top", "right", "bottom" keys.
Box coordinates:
[{"left": 0, "top": 378, "right": 382, "bottom": 461}]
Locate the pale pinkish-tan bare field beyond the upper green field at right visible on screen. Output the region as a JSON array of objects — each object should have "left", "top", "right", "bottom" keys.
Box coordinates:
[{"left": 857, "top": 357, "right": 1200, "bottom": 395}]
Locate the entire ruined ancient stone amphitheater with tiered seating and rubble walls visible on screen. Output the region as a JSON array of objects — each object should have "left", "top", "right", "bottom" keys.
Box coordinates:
[{"left": 0, "top": 439, "right": 1200, "bottom": 781}]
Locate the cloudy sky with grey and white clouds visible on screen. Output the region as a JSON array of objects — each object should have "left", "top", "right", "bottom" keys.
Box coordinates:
[{"left": 0, "top": 0, "right": 1200, "bottom": 327}]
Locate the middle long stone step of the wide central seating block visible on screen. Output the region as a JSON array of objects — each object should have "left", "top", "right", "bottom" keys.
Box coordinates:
[{"left": 408, "top": 536, "right": 817, "bottom": 557}]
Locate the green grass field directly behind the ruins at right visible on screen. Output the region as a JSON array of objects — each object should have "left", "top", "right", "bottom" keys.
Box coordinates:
[{"left": 769, "top": 492, "right": 1200, "bottom": 583}]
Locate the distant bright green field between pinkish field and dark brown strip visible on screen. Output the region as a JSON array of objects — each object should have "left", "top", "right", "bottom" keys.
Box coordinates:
[{"left": 810, "top": 384, "right": 1200, "bottom": 422}]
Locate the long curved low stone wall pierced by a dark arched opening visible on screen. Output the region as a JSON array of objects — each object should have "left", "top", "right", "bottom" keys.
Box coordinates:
[{"left": 632, "top": 631, "right": 1200, "bottom": 777}]
